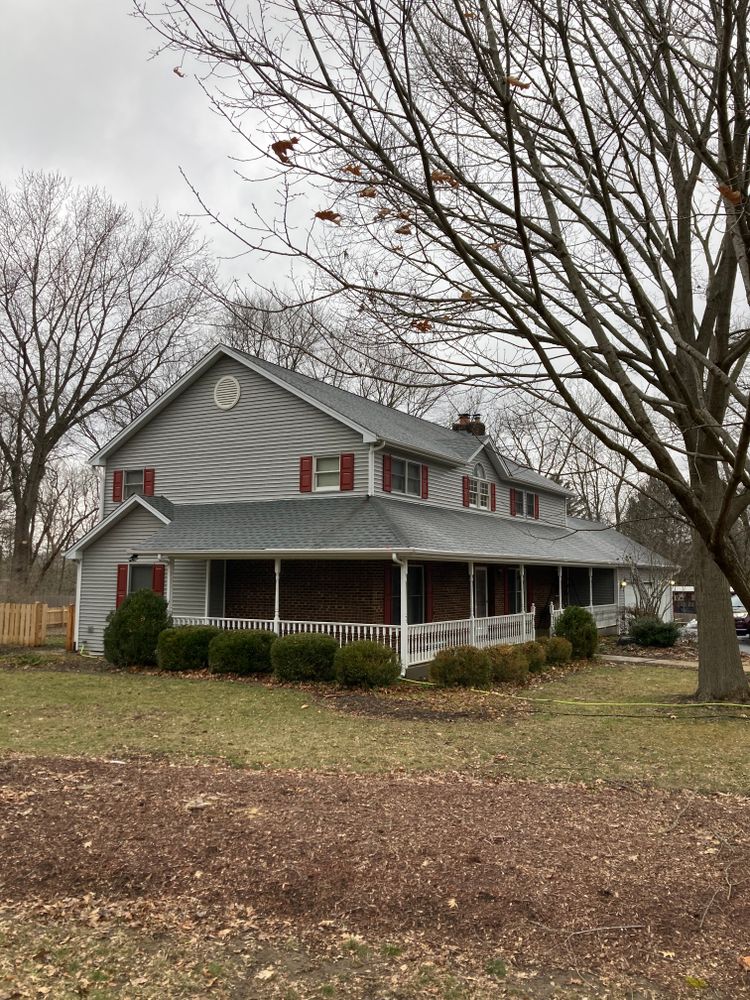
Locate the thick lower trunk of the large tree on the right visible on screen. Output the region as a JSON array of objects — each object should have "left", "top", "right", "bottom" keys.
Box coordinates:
[{"left": 693, "top": 532, "right": 750, "bottom": 701}]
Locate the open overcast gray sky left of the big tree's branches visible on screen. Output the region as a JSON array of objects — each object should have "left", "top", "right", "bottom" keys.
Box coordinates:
[{"left": 0, "top": 0, "right": 263, "bottom": 277}]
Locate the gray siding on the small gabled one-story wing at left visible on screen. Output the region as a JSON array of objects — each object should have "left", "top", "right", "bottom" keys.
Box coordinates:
[{"left": 78, "top": 507, "right": 162, "bottom": 653}]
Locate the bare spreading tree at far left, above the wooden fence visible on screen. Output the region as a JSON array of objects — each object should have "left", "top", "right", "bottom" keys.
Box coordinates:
[{"left": 0, "top": 173, "right": 209, "bottom": 596}]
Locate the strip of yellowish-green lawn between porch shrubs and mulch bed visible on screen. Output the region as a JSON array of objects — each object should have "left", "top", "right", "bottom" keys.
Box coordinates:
[{"left": 0, "top": 661, "right": 750, "bottom": 794}]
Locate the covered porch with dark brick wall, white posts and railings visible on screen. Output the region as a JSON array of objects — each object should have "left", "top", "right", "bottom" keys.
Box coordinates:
[{"left": 172, "top": 556, "right": 620, "bottom": 670}]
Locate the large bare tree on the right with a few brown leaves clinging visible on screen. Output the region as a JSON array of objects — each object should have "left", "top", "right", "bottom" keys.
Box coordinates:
[{"left": 136, "top": 0, "right": 750, "bottom": 699}]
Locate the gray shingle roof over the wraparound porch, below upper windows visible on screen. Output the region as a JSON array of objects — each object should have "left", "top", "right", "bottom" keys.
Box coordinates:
[{"left": 140, "top": 497, "right": 663, "bottom": 566}]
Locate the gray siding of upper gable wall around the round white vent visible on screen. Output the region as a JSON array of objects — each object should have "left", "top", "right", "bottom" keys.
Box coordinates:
[{"left": 104, "top": 358, "right": 369, "bottom": 514}]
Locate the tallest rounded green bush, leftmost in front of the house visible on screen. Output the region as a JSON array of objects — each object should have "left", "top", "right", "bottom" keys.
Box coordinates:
[{"left": 104, "top": 590, "right": 172, "bottom": 667}]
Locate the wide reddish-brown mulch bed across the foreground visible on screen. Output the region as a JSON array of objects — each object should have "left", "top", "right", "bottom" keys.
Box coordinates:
[{"left": 0, "top": 757, "right": 750, "bottom": 997}]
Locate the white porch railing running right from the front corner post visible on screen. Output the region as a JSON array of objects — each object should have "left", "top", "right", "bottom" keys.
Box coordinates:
[{"left": 408, "top": 607, "right": 534, "bottom": 664}]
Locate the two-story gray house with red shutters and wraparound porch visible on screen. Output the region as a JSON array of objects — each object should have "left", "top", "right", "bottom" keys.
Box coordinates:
[{"left": 67, "top": 346, "right": 671, "bottom": 668}]
